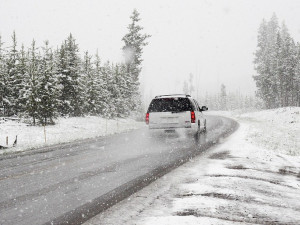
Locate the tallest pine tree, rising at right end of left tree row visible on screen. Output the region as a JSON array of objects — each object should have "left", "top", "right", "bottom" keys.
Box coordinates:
[{"left": 122, "top": 9, "right": 150, "bottom": 111}]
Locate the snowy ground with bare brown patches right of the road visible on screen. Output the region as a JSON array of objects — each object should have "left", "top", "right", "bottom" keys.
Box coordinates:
[{"left": 86, "top": 107, "right": 300, "bottom": 225}]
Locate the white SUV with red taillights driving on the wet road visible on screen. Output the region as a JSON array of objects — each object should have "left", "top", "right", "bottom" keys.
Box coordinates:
[{"left": 146, "top": 94, "right": 208, "bottom": 132}]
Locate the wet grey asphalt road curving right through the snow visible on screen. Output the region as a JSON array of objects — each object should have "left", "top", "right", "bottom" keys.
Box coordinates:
[{"left": 0, "top": 116, "right": 237, "bottom": 225}]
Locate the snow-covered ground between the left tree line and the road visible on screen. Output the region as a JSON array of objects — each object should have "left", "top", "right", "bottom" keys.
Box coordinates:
[{"left": 0, "top": 116, "right": 145, "bottom": 154}]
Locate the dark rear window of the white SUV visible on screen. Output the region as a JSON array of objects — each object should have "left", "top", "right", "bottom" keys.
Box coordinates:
[{"left": 148, "top": 98, "right": 193, "bottom": 113}]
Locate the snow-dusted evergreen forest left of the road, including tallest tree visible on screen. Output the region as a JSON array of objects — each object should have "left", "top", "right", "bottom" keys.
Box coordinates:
[{"left": 0, "top": 10, "right": 150, "bottom": 125}]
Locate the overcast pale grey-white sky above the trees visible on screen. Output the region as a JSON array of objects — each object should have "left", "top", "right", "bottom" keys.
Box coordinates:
[{"left": 0, "top": 0, "right": 300, "bottom": 102}]
